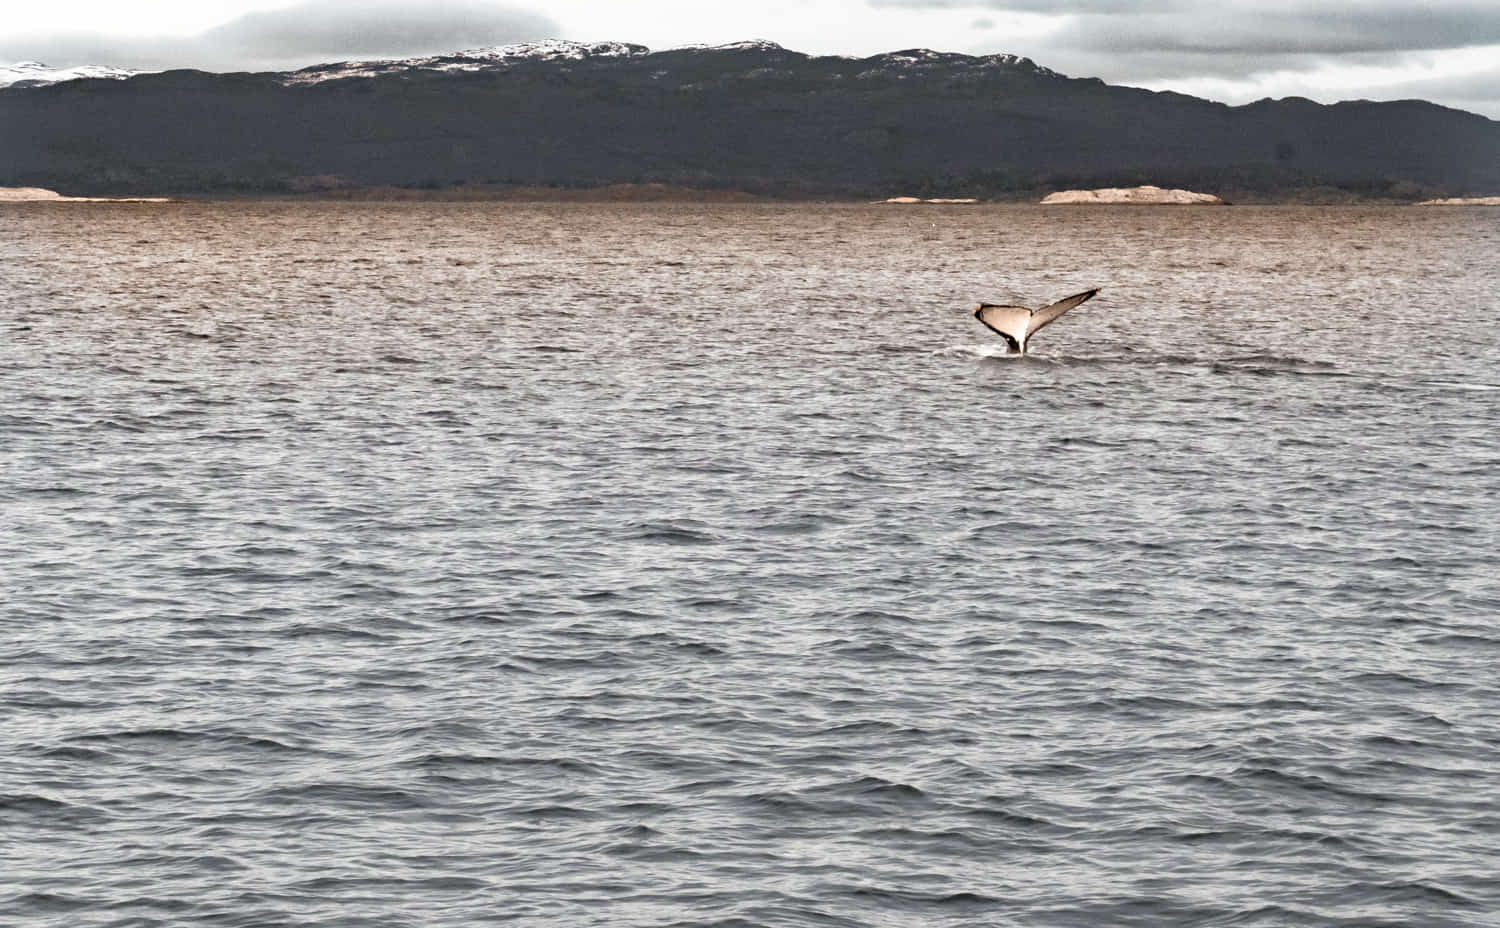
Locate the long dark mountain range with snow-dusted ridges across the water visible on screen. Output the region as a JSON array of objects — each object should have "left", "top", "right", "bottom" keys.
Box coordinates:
[{"left": 0, "top": 40, "right": 1500, "bottom": 199}]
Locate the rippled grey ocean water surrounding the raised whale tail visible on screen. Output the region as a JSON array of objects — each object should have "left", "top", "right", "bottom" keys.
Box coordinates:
[{"left": 0, "top": 204, "right": 1500, "bottom": 928}]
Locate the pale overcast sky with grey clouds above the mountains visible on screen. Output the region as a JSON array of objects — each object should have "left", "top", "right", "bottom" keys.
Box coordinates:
[{"left": 0, "top": 0, "right": 1500, "bottom": 118}]
